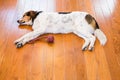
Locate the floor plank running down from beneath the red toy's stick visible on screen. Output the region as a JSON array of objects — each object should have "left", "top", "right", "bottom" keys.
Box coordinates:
[{"left": 30, "top": 42, "right": 49, "bottom": 80}]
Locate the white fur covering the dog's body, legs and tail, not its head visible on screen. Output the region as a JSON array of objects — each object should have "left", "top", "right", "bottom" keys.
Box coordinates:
[{"left": 15, "top": 12, "right": 107, "bottom": 50}]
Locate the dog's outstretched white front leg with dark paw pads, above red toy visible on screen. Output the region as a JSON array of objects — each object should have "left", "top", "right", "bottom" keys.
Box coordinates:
[{"left": 15, "top": 30, "right": 44, "bottom": 48}]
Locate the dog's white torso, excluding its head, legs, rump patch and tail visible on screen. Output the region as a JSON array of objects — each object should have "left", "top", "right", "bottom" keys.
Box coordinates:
[{"left": 33, "top": 12, "right": 91, "bottom": 33}]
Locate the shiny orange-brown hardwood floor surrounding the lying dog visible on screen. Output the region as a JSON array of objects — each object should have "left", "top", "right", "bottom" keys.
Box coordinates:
[{"left": 0, "top": 0, "right": 120, "bottom": 80}]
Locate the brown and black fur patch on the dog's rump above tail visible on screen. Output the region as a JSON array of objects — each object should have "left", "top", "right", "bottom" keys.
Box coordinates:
[{"left": 85, "top": 14, "right": 99, "bottom": 29}]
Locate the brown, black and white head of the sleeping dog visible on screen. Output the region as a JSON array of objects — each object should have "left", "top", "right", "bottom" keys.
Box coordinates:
[{"left": 17, "top": 11, "right": 42, "bottom": 25}]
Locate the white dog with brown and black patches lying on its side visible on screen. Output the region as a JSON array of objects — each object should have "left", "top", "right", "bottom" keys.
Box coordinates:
[{"left": 15, "top": 10, "right": 107, "bottom": 51}]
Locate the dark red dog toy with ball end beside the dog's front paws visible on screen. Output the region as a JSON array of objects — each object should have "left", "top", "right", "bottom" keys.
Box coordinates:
[{"left": 28, "top": 35, "right": 54, "bottom": 44}]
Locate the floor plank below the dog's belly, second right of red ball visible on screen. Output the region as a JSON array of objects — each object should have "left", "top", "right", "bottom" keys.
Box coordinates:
[{"left": 64, "top": 35, "right": 77, "bottom": 80}]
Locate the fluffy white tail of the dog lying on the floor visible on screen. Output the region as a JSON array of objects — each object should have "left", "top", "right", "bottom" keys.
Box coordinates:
[{"left": 94, "top": 29, "right": 107, "bottom": 46}]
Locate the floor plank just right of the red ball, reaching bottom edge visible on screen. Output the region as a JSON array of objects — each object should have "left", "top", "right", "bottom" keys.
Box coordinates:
[{"left": 53, "top": 34, "right": 66, "bottom": 80}]
